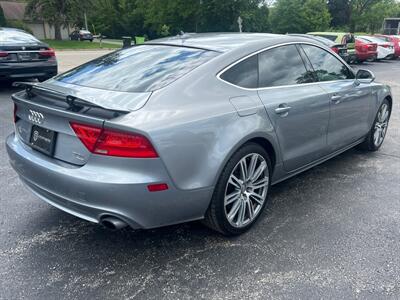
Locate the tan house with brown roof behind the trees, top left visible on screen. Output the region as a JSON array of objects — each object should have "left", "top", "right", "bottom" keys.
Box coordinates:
[{"left": 0, "top": 1, "right": 73, "bottom": 40}]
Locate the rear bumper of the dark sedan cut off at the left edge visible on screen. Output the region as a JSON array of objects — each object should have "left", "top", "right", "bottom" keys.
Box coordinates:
[{"left": 0, "top": 61, "right": 58, "bottom": 80}]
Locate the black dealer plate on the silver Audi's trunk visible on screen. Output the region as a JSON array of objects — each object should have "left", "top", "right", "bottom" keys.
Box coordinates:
[{"left": 29, "top": 125, "right": 57, "bottom": 156}]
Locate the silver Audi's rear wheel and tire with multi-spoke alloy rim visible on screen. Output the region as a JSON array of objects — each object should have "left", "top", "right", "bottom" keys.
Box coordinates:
[{"left": 203, "top": 143, "right": 272, "bottom": 236}]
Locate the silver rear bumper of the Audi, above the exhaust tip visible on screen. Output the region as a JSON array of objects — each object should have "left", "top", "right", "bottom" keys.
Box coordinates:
[{"left": 6, "top": 134, "right": 212, "bottom": 228}]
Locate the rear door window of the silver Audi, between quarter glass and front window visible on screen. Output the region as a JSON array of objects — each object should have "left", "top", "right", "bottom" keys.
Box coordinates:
[{"left": 259, "top": 45, "right": 314, "bottom": 87}]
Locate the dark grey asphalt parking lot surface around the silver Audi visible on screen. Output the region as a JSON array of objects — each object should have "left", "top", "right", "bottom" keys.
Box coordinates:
[{"left": 0, "top": 57, "right": 400, "bottom": 299}]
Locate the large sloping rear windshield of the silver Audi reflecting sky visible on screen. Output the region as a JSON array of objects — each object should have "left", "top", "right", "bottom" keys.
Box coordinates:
[{"left": 56, "top": 45, "right": 218, "bottom": 92}]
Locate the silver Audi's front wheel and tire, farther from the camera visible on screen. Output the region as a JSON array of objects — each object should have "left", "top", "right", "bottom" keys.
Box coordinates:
[{"left": 359, "top": 99, "right": 391, "bottom": 151}]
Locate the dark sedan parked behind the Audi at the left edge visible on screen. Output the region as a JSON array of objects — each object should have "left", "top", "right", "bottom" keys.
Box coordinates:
[{"left": 0, "top": 28, "right": 57, "bottom": 81}]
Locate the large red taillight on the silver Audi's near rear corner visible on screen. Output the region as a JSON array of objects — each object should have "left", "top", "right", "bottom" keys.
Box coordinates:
[{"left": 71, "top": 123, "right": 158, "bottom": 158}]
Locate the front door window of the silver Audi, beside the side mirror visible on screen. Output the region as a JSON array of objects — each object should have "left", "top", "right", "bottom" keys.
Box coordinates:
[{"left": 302, "top": 45, "right": 354, "bottom": 81}]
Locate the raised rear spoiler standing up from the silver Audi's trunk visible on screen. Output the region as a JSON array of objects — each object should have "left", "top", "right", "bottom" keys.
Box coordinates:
[{"left": 13, "top": 81, "right": 129, "bottom": 114}]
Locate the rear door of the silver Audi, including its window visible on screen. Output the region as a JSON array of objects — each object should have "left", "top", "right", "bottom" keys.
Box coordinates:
[{"left": 258, "top": 44, "right": 329, "bottom": 172}]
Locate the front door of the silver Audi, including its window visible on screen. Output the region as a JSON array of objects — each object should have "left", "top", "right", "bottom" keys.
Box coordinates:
[{"left": 302, "top": 44, "right": 372, "bottom": 152}]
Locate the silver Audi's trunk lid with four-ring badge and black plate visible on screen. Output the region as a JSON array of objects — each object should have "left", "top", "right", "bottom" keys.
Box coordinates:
[{"left": 13, "top": 83, "right": 150, "bottom": 166}]
